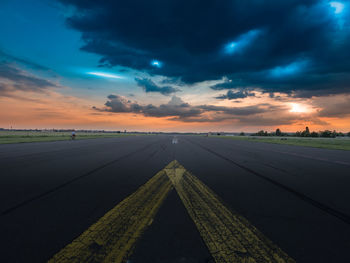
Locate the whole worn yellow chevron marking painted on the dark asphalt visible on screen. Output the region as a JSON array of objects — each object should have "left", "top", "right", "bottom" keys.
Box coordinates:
[{"left": 49, "top": 160, "right": 295, "bottom": 263}]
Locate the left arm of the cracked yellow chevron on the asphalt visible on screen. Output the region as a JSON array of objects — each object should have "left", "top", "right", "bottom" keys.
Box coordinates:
[{"left": 49, "top": 170, "right": 172, "bottom": 263}]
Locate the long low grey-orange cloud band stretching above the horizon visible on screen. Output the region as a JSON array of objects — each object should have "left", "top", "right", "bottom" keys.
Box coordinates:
[{"left": 93, "top": 94, "right": 350, "bottom": 126}]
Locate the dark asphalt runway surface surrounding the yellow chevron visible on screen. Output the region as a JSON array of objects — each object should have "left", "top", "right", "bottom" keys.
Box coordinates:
[{"left": 0, "top": 135, "right": 350, "bottom": 263}]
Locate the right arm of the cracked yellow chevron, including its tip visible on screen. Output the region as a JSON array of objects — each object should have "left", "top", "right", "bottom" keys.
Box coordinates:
[{"left": 165, "top": 160, "right": 295, "bottom": 263}]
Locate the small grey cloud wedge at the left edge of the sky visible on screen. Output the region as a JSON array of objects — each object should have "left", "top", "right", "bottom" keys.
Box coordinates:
[{"left": 0, "top": 62, "right": 57, "bottom": 95}]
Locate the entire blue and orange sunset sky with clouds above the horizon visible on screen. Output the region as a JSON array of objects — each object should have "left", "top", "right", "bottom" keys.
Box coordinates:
[{"left": 0, "top": 0, "right": 350, "bottom": 132}]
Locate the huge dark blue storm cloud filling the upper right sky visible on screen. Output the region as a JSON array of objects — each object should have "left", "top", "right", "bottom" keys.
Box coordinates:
[{"left": 61, "top": 0, "right": 350, "bottom": 97}]
